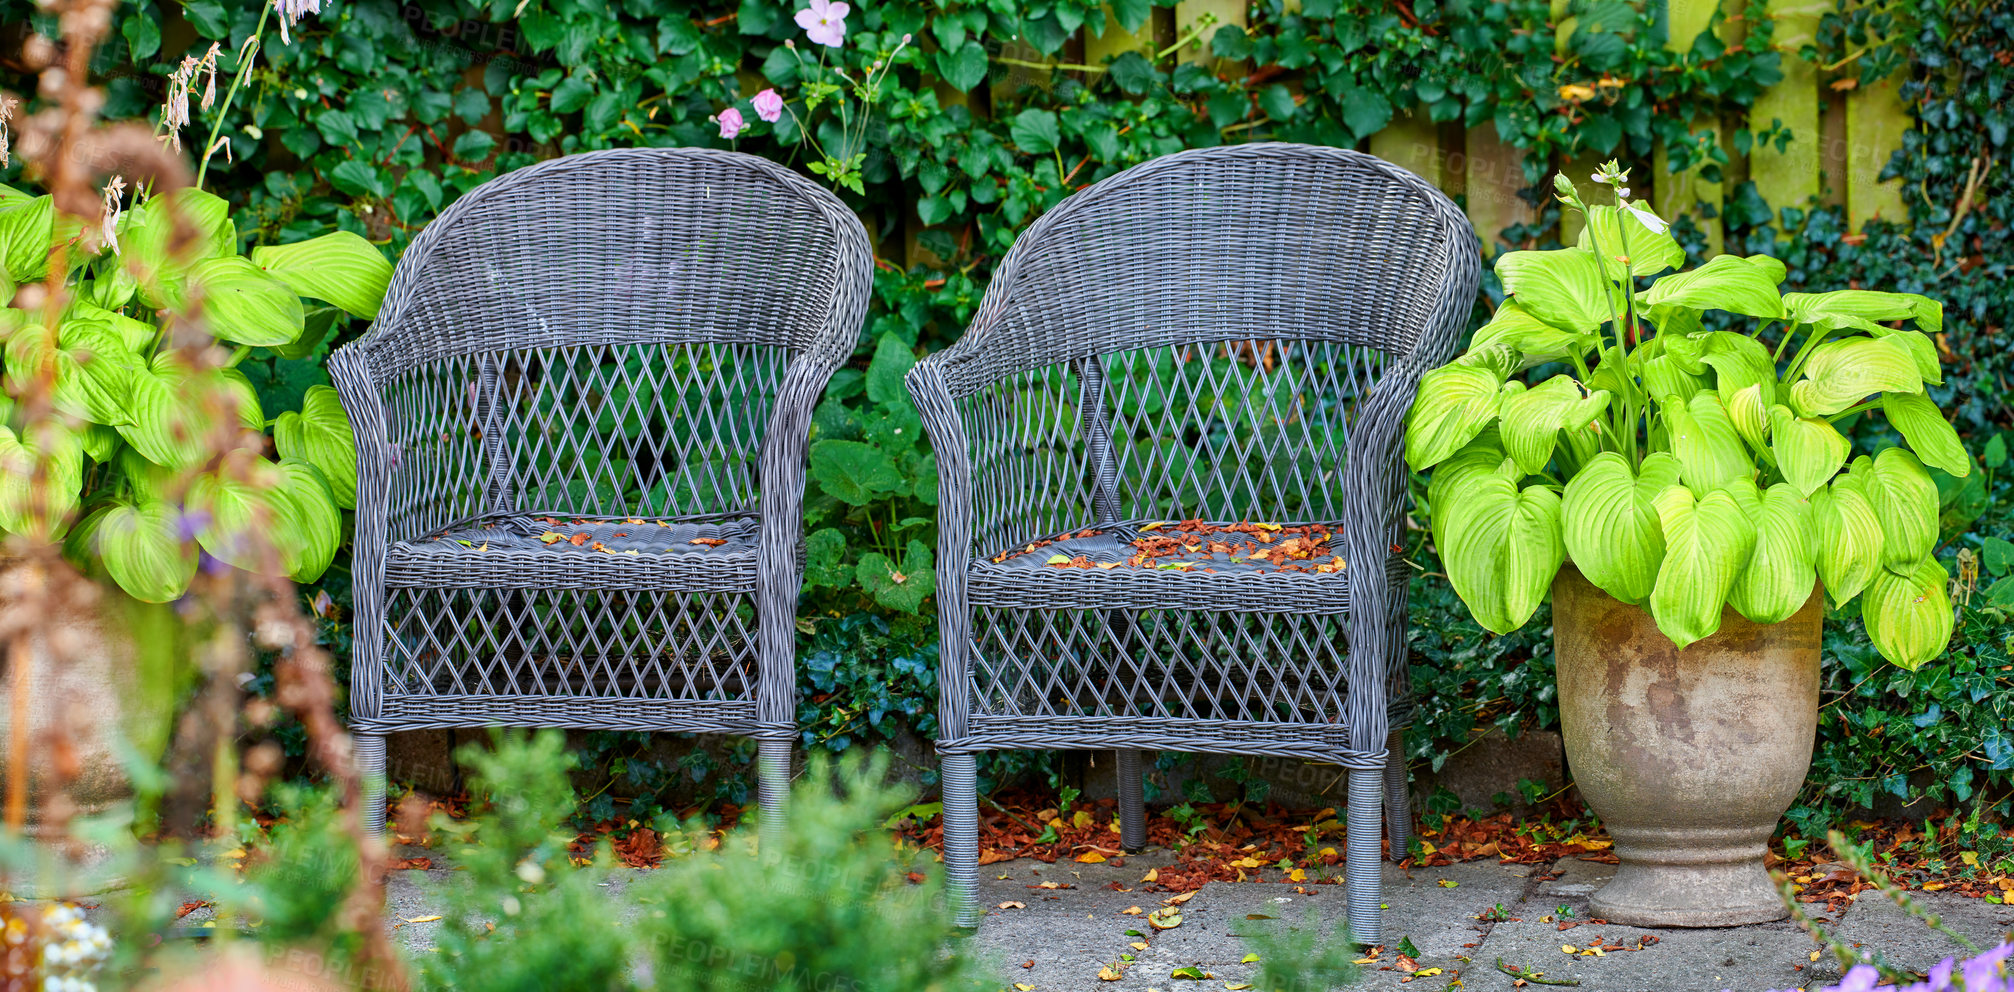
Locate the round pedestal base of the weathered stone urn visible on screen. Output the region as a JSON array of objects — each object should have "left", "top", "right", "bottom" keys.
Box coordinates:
[{"left": 1589, "top": 825, "right": 1790, "bottom": 926}]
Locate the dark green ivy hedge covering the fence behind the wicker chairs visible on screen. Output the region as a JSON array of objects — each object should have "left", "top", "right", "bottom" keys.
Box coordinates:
[{"left": 0, "top": 0, "right": 2014, "bottom": 819}]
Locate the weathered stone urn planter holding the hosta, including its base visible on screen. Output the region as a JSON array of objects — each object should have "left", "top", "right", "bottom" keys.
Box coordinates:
[{"left": 1553, "top": 565, "right": 1825, "bottom": 928}]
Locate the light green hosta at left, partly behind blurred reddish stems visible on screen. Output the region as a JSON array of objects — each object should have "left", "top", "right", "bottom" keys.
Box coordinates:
[{"left": 0, "top": 181, "right": 391, "bottom": 602}]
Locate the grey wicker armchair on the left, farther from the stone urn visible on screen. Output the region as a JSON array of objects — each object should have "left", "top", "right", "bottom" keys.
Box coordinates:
[{"left": 330, "top": 149, "right": 872, "bottom": 841}]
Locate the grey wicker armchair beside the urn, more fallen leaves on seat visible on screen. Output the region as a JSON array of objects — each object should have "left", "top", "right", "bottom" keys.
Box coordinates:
[{"left": 908, "top": 145, "right": 1480, "bottom": 942}]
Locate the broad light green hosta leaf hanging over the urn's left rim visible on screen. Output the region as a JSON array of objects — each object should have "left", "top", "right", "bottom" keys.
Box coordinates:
[{"left": 1561, "top": 451, "right": 1678, "bottom": 604}]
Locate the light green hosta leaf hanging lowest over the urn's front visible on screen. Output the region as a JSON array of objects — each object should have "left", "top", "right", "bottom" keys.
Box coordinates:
[{"left": 1649, "top": 485, "right": 1756, "bottom": 648}]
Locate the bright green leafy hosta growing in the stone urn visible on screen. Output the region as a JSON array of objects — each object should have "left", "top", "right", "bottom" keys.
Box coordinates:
[{"left": 1406, "top": 163, "right": 1972, "bottom": 668}]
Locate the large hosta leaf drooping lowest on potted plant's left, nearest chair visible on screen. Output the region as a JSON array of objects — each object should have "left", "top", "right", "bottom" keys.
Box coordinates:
[{"left": 1436, "top": 473, "right": 1565, "bottom": 634}]
